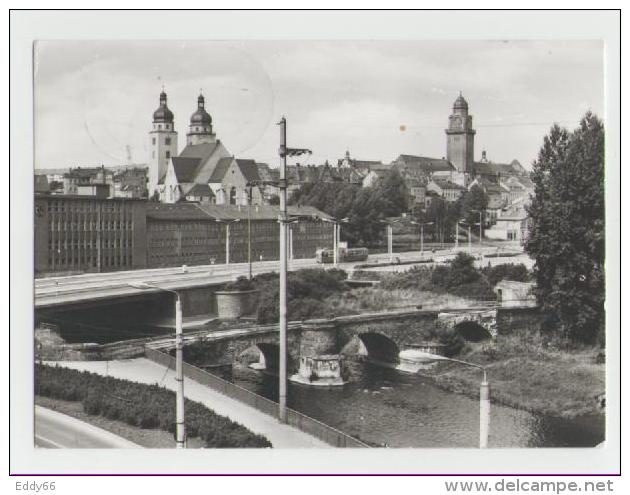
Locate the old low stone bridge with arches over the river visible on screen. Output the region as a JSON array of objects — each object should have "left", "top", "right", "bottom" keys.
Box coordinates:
[{"left": 154, "top": 308, "right": 540, "bottom": 370}]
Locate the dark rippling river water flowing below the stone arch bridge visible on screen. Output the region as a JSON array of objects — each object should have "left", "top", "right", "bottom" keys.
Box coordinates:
[{"left": 212, "top": 361, "right": 604, "bottom": 447}]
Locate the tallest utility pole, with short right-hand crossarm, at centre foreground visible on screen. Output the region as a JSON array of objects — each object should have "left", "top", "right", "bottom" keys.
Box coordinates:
[{"left": 278, "top": 117, "right": 311, "bottom": 423}]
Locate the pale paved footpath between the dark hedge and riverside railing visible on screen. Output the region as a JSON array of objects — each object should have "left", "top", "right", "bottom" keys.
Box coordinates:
[{"left": 48, "top": 358, "right": 330, "bottom": 448}]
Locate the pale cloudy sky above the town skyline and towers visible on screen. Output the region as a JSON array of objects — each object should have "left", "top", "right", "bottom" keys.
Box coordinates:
[{"left": 35, "top": 41, "right": 604, "bottom": 168}]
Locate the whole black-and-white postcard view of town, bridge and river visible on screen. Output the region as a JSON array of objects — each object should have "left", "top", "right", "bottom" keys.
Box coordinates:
[{"left": 11, "top": 6, "right": 620, "bottom": 480}]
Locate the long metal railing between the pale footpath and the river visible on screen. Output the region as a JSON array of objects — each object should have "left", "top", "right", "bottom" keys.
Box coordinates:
[{"left": 144, "top": 346, "right": 369, "bottom": 448}]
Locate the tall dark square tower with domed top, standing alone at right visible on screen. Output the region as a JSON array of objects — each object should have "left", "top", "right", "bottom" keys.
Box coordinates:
[{"left": 445, "top": 92, "right": 477, "bottom": 175}]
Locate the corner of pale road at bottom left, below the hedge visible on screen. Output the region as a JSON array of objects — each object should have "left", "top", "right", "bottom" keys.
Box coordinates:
[{"left": 35, "top": 406, "right": 142, "bottom": 449}]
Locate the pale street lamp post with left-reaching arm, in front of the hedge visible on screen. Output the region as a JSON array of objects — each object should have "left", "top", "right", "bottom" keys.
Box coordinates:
[{"left": 129, "top": 282, "right": 186, "bottom": 449}]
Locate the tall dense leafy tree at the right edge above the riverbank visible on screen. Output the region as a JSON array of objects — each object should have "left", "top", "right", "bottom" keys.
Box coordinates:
[{"left": 525, "top": 112, "right": 605, "bottom": 343}]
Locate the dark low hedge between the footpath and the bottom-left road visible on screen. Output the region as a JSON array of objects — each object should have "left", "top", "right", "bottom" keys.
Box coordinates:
[{"left": 35, "top": 364, "right": 272, "bottom": 448}]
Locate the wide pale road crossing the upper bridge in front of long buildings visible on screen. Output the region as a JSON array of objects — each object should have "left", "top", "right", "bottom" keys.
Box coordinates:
[{"left": 35, "top": 245, "right": 521, "bottom": 308}]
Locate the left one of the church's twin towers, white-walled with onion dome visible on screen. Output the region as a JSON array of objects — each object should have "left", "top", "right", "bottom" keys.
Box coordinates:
[{"left": 148, "top": 89, "right": 177, "bottom": 197}]
